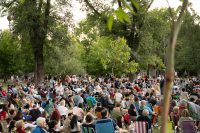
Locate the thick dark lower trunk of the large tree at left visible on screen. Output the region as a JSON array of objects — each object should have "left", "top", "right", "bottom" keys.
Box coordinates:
[{"left": 34, "top": 45, "right": 44, "bottom": 85}]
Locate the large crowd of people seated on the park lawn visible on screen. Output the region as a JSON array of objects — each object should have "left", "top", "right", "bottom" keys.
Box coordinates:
[{"left": 0, "top": 76, "right": 200, "bottom": 133}]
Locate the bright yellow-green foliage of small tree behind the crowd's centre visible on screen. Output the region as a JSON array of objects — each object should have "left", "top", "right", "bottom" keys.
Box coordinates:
[{"left": 88, "top": 37, "right": 137, "bottom": 75}]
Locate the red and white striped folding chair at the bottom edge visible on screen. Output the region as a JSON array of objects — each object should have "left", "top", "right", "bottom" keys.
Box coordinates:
[{"left": 135, "top": 121, "right": 151, "bottom": 133}]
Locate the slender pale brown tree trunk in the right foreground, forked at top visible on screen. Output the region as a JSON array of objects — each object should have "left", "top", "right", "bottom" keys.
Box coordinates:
[{"left": 160, "top": 0, "right": 188, "bottom": 133}]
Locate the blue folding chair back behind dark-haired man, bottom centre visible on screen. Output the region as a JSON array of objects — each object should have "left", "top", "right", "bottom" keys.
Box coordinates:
[{"left": 95, "top": 119, "right": 115, "bottom": 133}]
